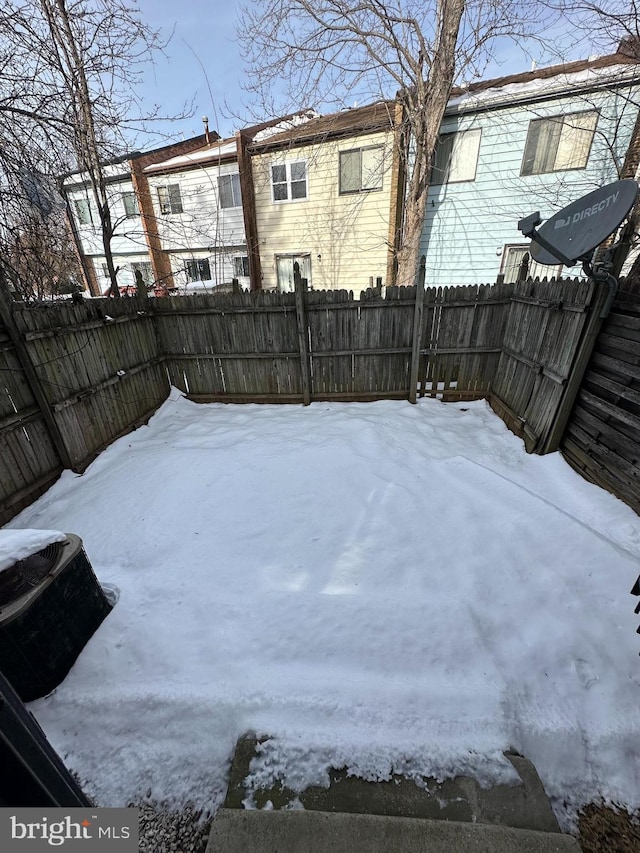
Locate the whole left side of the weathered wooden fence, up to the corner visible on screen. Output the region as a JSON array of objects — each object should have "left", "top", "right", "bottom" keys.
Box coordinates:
[{"left": 0, "top": 298, "right": 169, "bottom": 523}]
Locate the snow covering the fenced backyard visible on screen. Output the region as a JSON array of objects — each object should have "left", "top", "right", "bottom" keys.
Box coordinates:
[{"left": 9, "top": 392, "right": 640, "bottom": 824}]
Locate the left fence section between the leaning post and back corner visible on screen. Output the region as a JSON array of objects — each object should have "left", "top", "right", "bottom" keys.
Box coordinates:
[{"left": 12, "top": 298, "right": 169, "bottom": 471}]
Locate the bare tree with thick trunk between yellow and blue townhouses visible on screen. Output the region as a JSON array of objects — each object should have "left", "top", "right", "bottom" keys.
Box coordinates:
[{"left": 238, "top": 0, "right": 538, "bottom": 284}]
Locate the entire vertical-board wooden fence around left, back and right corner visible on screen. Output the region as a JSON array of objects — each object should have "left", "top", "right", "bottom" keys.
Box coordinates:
[{"left": 0, "top": 274, "right": 616, "bottom": 521}]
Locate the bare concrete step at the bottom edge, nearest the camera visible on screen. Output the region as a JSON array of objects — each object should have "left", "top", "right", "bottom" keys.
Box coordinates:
[{"left": 206, "top": 809, "right": 580, "bottom": 853}]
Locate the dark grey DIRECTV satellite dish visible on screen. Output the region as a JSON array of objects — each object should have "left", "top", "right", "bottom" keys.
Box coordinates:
[{"left": 518, "top": 179, "right": 638, "bottom": 267}]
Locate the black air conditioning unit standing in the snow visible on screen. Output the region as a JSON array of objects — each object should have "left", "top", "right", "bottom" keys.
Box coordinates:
[{"left": 0, "top": 533, "right": 111, "bottom": 702}]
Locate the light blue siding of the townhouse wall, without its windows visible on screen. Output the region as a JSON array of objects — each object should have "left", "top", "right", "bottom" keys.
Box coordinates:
[{"left": 420, "top": 84, "right": 639, "bottom": 285}]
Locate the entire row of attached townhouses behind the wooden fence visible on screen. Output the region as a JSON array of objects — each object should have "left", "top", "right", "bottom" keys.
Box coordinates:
[{"left": 65, "top": 43, "right": 640, "bottom": 294}]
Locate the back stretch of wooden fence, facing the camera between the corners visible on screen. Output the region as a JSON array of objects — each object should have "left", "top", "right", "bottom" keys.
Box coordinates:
[{"left": 154, "top": 285, "right": 512, "bottom": 402}]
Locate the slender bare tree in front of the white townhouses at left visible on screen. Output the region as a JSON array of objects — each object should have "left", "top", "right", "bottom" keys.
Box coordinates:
[{"left": 0, "top": 0, "right": 174, "bottom": 296}]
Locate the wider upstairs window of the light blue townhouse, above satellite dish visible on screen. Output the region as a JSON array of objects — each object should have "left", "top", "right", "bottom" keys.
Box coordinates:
[{"left": 520, "top": 110, "right": 598, "bottom": 175}]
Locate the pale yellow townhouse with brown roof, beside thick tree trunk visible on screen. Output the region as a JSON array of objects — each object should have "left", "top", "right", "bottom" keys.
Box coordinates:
[{"left": 243, "top": 101, "right": 398, "bottom": 293}]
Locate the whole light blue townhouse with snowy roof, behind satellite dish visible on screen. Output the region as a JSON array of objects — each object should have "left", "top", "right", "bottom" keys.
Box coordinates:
[{"left": 420, "top": 44, "right": 640, "bottom": 285}]
